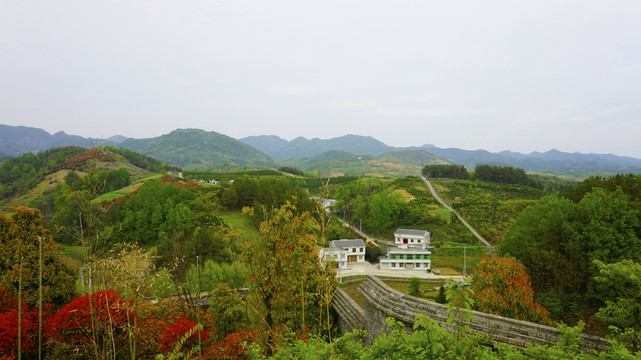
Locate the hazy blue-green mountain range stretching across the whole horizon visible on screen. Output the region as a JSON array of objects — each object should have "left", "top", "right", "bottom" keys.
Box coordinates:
[{"left": 0, "top": 125, "right": 641, "bottom": 176}]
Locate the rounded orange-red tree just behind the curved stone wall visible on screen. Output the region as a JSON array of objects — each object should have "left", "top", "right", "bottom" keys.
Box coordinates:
[{"left": 472, "top": 257, "right": 554, "bottom": 325}]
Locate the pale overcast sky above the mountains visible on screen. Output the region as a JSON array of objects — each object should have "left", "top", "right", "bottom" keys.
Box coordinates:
[{"left": 0, "top": 0, "right": 641, "bottom": 158}]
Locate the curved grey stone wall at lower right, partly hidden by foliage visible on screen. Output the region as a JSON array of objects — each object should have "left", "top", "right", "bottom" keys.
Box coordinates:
[{"left": 334, "top": 276, "right": 607, "bottom": 351}]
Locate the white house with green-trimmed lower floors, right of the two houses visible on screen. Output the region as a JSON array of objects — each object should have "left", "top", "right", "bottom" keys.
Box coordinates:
[{"left": 380, "top": 229, "right": 432, "bottom": 270}]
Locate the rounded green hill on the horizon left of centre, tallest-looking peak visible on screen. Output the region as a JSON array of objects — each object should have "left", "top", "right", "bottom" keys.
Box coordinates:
[{"left": 120, "top": 129, "right": 276, "bottom": 170}]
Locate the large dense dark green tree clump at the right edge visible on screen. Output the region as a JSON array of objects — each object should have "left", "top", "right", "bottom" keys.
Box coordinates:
[{"left": 498, "top": 188, "right": 641, "bottom": 321}]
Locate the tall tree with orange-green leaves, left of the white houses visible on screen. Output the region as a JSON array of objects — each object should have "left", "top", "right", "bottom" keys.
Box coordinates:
[{"left": 243, "top": 202, "right": 334, "bottom": 354}]
